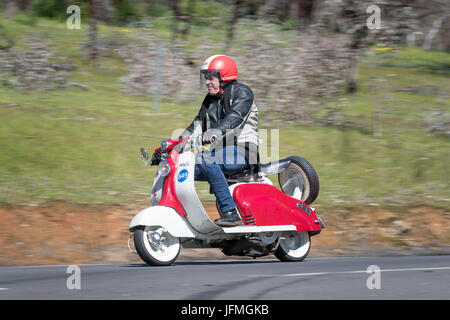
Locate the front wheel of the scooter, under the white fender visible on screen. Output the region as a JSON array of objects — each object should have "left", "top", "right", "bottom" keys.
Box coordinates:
[{"left": 134, "top": 226, "right": 181, "bottom": 266}]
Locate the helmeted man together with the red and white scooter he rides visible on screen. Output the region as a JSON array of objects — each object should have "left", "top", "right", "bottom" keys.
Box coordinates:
[{"left": 134, "top": 55, "right": 324, "bottom": 266}]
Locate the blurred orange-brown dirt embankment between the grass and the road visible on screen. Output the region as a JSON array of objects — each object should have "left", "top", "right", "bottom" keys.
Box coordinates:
[{"left": 0, "top": 202, "right": 450, "bottom": 266}]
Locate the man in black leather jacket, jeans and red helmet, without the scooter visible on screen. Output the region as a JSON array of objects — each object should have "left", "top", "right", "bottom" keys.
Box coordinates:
[{"left": 180, "top": 55, "right": 258, "bottom": 227}]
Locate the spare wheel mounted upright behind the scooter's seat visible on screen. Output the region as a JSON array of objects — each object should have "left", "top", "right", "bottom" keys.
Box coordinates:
[{"left": 278, "top": 156, "right": 319, "bottom": 204}]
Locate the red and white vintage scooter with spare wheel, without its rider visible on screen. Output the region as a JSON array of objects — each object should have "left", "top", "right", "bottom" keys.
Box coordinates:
[{"left": 128, "top": 137, "right": 325, "bottom": 266}]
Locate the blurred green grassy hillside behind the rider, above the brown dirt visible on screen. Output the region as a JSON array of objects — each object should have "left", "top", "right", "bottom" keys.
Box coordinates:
[{"left": 0, "top": 19, "right": 450, "bottom": 208}]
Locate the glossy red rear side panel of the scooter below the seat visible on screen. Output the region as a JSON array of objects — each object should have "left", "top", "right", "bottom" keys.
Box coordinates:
[{"left": 233, "top": 183, "right": 321, "bottom": 231}]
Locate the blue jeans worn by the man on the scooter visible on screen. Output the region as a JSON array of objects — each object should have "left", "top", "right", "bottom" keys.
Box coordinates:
[{"left": 194, "top": 146, "right": 247, "bottom": 212}]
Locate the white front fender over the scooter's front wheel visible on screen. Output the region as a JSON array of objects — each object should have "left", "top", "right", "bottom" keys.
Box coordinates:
[{"left": 129, "top": 206, "right": 197, "bottom": 238}]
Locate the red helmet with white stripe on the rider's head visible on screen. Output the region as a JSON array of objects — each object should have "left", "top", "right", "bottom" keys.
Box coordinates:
[{"left": 200, "top": 54, "right": 237, "bottom": 82}]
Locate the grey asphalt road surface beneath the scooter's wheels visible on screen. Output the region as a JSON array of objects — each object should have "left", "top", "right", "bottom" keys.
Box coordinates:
[{"left": 0, "top": 255, "right": 450, "bottom": 300}]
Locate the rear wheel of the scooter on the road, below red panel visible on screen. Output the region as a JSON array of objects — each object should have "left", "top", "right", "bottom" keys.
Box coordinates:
[{"left": 275, "top": 231, "right": 311, "bottom": 262}]
